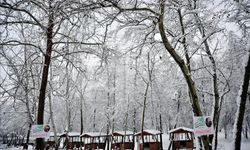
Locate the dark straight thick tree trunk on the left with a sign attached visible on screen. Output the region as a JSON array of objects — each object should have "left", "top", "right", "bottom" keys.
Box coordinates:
[{"left": 36, "top": 0, "right": 54, "bottom": 150}]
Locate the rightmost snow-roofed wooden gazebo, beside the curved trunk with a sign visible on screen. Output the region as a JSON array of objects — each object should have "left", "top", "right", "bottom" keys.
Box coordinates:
[{"left": 168, "top": 127, "right": 195, "bottom": 150}]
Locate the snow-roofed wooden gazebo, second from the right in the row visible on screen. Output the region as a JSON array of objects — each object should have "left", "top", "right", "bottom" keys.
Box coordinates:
[{"left": 135, "top": 130, "right": 163, "bottom": 150}]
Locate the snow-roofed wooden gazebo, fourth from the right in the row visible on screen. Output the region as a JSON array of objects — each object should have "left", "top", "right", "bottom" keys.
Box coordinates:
[{"left": 81, "top": 132, "right": 107, "bottom": 150}]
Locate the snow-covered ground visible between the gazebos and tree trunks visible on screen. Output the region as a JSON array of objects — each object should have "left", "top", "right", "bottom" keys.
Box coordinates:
[{"left": 0, "top": 134, "right": 250, "bottom": 150}]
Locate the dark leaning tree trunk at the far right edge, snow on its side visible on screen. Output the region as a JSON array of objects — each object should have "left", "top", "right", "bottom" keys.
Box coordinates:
[{"left": 233, "top": 52, "right": 250, "bottom": 150}]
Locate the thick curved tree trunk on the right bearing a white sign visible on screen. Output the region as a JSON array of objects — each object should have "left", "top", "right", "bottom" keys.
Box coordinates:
[{"left": 158, "top": 0, "right": 211, "bottom": 150}]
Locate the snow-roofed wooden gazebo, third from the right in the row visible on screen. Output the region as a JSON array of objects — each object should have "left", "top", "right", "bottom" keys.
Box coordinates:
[{"left": 111, "top": 131, "right": 134, "bottom": 150}]
